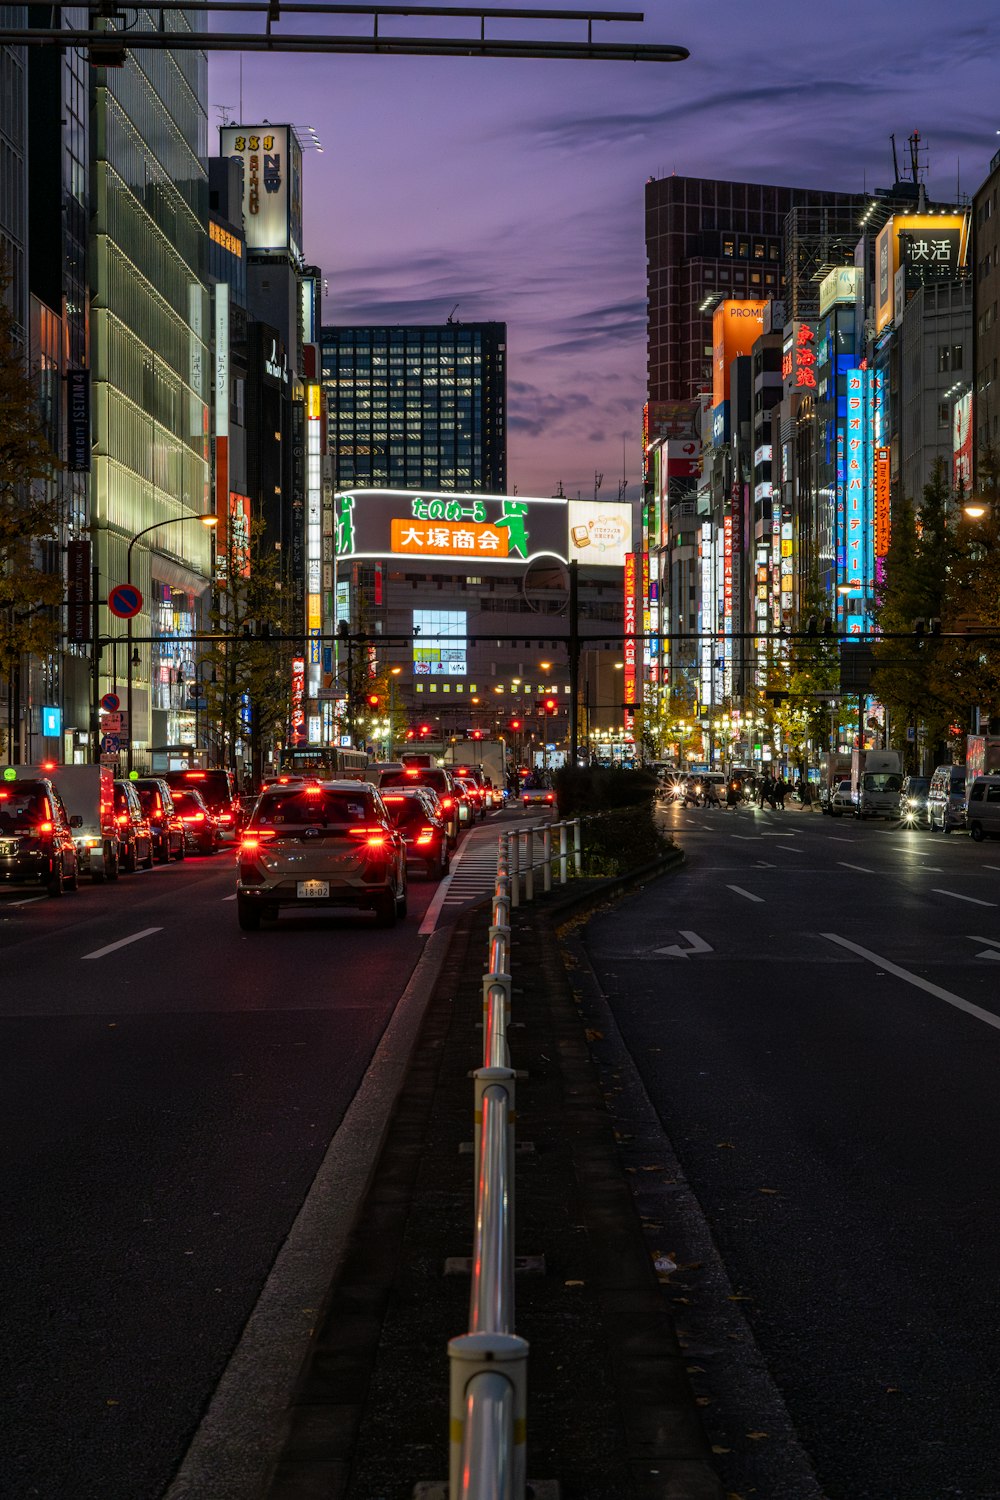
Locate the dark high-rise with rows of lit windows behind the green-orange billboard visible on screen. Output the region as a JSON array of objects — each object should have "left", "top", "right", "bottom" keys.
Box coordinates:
[{"left": 322, "top": 323, "right": 507, "bottom": 495}]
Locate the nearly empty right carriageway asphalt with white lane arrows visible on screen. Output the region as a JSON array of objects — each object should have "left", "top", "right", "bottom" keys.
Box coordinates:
[{"left": 586, "top": 809, "right": 1000, "bottom": 1500}]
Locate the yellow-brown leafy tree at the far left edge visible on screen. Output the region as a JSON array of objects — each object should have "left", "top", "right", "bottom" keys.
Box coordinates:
[{"left": 0, "top": 264, "right": 63, "bottom": 759}]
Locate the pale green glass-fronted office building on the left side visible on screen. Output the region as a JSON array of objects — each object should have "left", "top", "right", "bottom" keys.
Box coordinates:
[{"left": 91, "top": 21, "right": 213, "bottom": 765}]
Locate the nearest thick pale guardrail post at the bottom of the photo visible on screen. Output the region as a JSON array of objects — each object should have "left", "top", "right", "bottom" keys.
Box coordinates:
[{"left": 448, "top": 1334, "right": 528, "bottom": 1500}]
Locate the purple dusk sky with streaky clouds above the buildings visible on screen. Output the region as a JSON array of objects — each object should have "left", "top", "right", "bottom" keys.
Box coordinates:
[{"left": 208, "top": 0, "right": 1000, "bottom": 500}]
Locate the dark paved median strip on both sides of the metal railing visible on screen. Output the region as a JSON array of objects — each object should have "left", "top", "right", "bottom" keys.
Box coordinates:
[{"left": 267, "top": 858, "right": 723, "bottom": 1500}]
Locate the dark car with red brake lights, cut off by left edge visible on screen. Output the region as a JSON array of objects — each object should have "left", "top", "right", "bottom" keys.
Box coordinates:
[{"left": 0, "top": 777, "right": 82, "bottom": 896}]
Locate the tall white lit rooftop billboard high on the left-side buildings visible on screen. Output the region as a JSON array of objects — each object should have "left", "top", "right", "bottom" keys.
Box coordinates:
[{"left": 220, "top": 125, "right": 301, "bottom": 260}]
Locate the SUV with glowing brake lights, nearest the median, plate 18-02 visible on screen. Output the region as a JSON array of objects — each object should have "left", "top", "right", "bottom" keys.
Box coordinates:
[{"left": 237, "top": 782, "right": 406, "bottom": 932}]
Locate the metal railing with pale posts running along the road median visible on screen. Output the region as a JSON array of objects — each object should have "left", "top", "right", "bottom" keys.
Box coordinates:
[{"left": 448, "top": 818, "right": 582, "bottom": 1500}]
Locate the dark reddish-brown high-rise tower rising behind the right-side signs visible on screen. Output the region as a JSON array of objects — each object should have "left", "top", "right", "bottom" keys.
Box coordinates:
[{"left": 646, "top": 177, "right": 865, "bottom": 402}]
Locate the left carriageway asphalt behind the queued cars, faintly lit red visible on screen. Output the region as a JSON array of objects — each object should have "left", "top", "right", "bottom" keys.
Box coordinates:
[{"left": 0, "top": 815, "right": 507, "bottom": 1500}]
